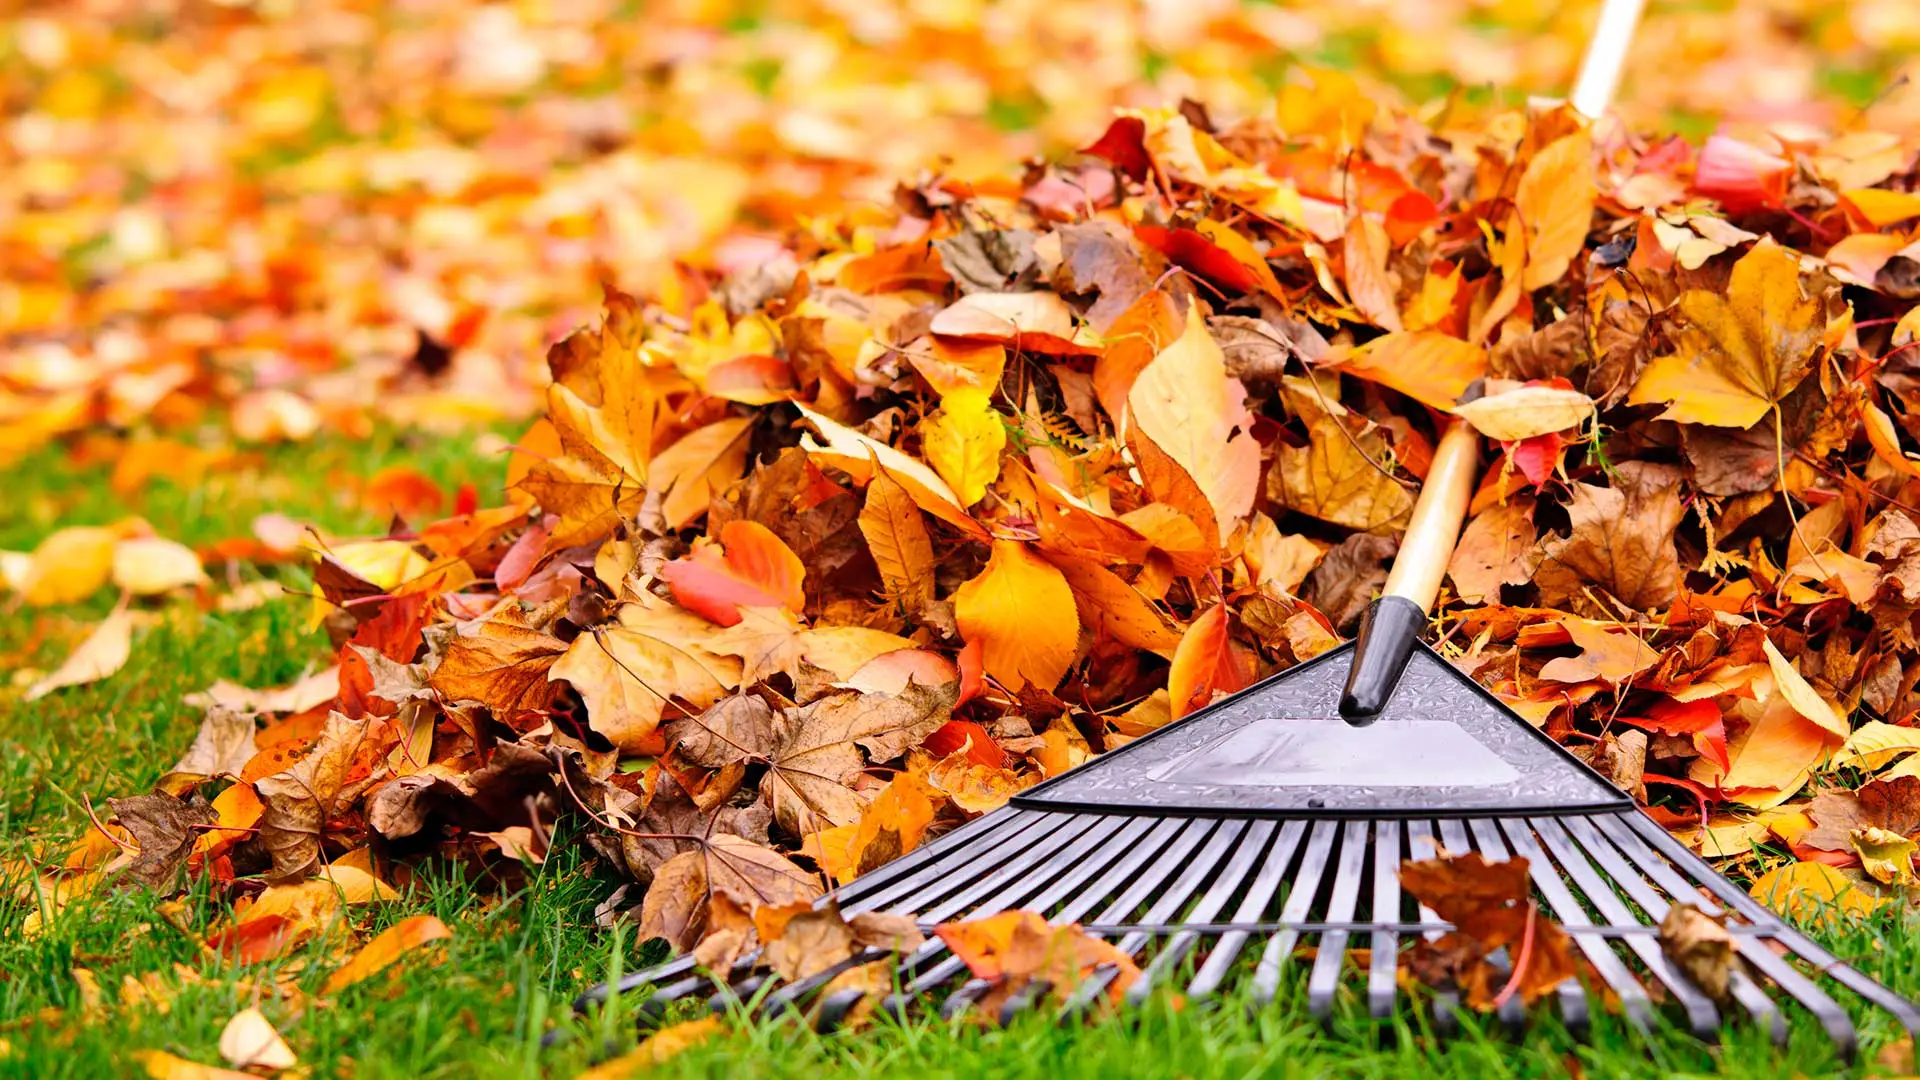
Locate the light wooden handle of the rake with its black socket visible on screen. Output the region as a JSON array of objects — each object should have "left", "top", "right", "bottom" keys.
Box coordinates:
[{"left": 1340, "top": 0, "right": 1645, "bottom": 726}]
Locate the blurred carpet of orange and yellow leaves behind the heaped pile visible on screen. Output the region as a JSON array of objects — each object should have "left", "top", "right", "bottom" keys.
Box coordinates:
[{"left": 0, "top": 0, "right": 1920, "bottom": 463}]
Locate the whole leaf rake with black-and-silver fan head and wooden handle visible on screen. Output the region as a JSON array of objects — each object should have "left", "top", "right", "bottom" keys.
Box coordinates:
[{"left": 576, "top": 0, "right": 1920, "bottom": 1057}]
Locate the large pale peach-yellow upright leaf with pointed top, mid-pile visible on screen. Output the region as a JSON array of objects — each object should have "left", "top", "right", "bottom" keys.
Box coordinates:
[{"left": 1127, "top": 302, "right": 1260, "bottom": 536}]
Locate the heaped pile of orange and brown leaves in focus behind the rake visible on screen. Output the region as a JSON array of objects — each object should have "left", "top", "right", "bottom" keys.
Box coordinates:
[{"left": 18, "top": 82, "right": 1920, "bottom": 1014}]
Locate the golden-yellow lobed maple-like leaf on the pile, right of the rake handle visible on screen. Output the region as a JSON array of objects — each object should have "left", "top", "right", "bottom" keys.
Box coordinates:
[{"left": 1626, "top": 238, "right": 1826, "bottom": 429}]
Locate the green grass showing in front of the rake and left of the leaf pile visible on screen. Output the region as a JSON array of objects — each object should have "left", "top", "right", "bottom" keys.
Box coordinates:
[{"left": 0, "top": 432, "right": 1920, "bottom": 1080}]
